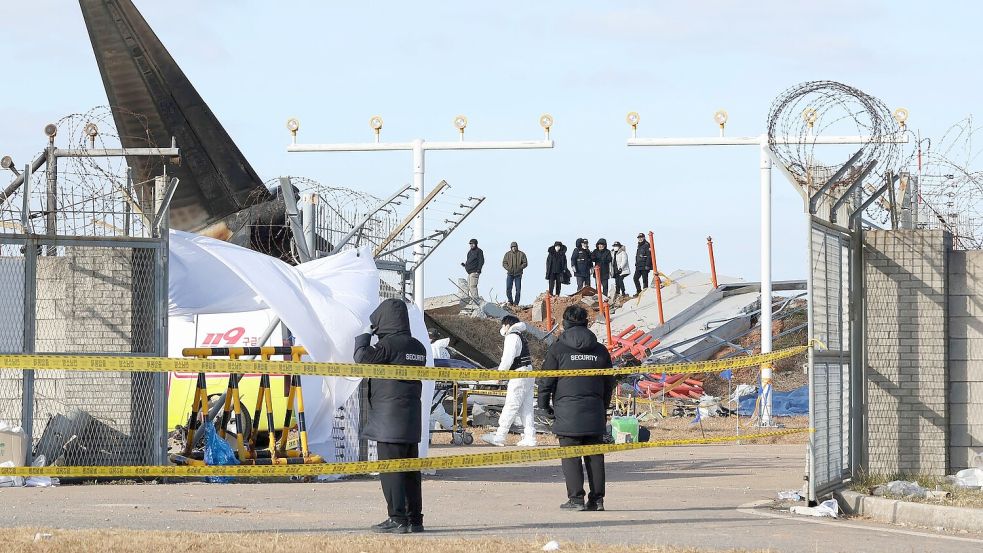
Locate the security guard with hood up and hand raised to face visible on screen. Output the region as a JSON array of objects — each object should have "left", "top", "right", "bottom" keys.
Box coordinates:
[{"left": 355, "top": 299, "right": 427, "bottom": 534}]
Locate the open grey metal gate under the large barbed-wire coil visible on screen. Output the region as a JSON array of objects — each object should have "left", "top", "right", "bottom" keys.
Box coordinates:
[{"left": 807, "top": 216, "right": 862, "bottom": 501}]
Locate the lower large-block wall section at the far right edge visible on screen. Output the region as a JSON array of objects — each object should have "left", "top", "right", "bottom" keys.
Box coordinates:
[{"left": 949, "top": 251, "right": 983, "bottom": 472}]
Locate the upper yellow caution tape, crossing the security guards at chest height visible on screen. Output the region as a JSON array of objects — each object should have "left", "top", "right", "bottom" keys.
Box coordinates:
[{"left": 0, "top": 345, "right": 810, "bottom": 380}]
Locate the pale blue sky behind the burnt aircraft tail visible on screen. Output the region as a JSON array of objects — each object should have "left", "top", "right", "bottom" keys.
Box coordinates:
[{"left": 0, "top": 0, "right": 983, "bottom": 299}]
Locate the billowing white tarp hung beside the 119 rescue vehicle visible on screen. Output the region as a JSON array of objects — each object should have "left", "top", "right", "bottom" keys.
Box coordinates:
[{"left": 168, "top": 230, "right": 433, "bottom": 460}]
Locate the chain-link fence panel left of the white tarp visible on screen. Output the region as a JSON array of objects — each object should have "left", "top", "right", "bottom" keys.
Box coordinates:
[{"left": 0, "top": 235, "right": 166, "bottom": 465}]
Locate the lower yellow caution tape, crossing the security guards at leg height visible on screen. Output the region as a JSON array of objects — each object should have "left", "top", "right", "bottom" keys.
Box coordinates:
[{"left": 0, "top": 428, "right": 812, "bottom": 478}]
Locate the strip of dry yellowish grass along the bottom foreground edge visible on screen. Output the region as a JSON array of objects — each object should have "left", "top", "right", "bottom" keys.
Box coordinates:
[{"left": 0, "top": 528, "right": 776, "bottom": 553}]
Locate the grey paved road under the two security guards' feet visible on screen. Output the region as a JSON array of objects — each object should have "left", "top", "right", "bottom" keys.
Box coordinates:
[{"left": 0, "top": 445, "right": 983, "bottom": 553}]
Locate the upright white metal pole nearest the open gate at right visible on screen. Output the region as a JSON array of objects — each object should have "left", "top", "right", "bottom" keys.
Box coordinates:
[{"left": 760, "top": 134, "right": 772, "bottom": 426}]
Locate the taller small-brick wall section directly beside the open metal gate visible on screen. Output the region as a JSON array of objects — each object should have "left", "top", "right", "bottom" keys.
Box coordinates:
[{"left": 864, "top": 230, "right": 951, "bottom": 476}]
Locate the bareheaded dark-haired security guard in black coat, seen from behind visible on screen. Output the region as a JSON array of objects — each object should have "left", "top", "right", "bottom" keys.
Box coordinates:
[{"left": 537, "top": 305, "right": 615, "bottom": 511}]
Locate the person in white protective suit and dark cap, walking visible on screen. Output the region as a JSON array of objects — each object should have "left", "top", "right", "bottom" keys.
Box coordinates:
[{"left": 481, "top": 315, "right": 536, "bottom": 447}]
